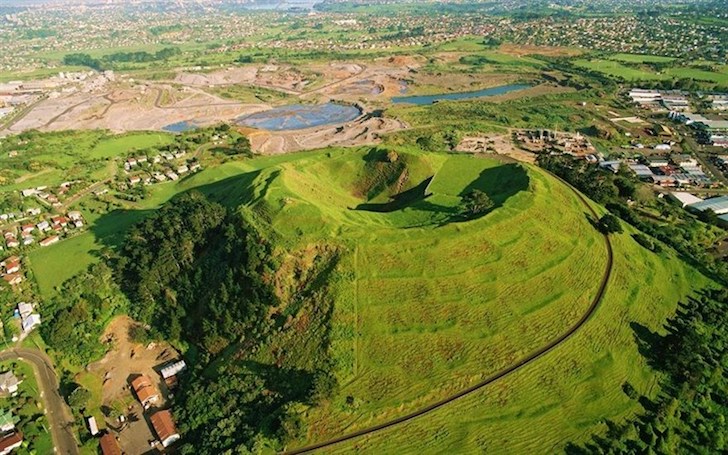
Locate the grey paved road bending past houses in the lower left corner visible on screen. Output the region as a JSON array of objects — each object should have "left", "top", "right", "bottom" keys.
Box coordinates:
[{"left": 0, "top": 348, "right": 78, "bottom": 455}]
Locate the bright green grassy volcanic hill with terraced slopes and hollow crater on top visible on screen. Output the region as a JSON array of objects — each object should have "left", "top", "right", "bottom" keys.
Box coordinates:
[{"left": 29, "top": 149, "right": 707, "bottom": 453}]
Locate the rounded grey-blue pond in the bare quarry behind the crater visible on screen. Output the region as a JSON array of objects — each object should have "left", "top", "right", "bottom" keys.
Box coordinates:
[{"left": 236, "top": 103, "right": 361, "bottom": 131}]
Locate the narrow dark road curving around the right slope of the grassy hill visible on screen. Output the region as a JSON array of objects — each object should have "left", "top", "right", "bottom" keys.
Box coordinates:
[{"left": 284, "top": 171, "right": 614, "bottom": 455}]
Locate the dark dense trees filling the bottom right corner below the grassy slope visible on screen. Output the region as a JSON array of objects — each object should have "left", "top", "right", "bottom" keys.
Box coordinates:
[{"left": 566, "top": 289, "right": 728, "bottom": 454}]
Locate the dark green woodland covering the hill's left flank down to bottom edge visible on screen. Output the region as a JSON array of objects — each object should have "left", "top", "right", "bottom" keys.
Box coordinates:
[{"left": 117, "top": 192, "right": 336, "bottom": 454}]
